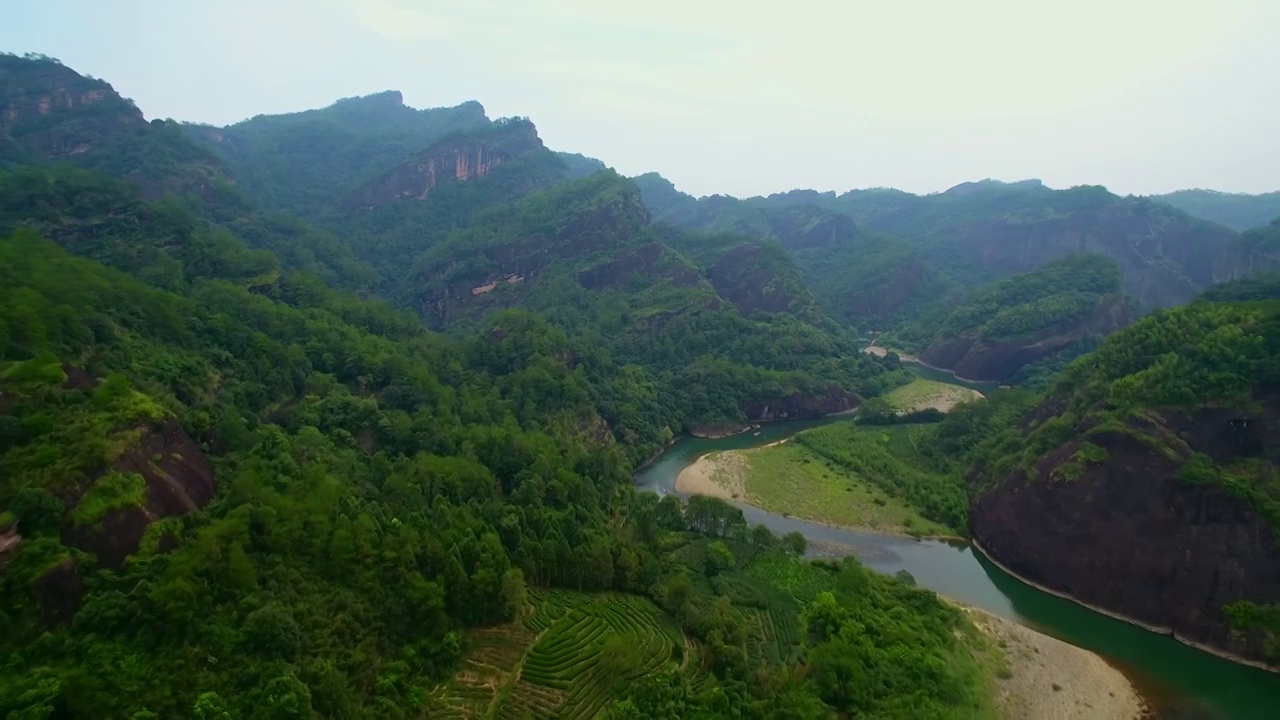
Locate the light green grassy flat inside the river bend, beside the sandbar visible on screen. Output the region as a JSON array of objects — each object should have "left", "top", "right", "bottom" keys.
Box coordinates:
[{"left": 731, "top": 435, "right": 955, "bottom": 534}]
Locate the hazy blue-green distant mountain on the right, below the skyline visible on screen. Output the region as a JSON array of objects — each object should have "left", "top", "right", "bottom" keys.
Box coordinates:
[{"left": 832, "top": 181, "right": 1235, "bottom": 307}]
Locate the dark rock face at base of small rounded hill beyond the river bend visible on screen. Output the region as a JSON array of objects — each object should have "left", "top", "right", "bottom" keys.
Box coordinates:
[{"left": 920, "top": 296, "right": 1133, "bottom": 382}]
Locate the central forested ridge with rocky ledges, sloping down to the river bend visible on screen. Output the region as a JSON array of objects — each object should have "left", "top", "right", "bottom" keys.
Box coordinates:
[{"left": 411, "top": 172, "right": 881, "bottom": 432}]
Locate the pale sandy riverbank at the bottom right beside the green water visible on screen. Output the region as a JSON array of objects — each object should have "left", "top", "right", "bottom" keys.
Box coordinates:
[{"left": 961, "top": 606, "right": 1146, "bottom": 720}]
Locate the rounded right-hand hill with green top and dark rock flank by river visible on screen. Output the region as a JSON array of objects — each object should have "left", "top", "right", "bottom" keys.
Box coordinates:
[{"left": 969, "top": 292, "right": 1280, "bottom": 666}]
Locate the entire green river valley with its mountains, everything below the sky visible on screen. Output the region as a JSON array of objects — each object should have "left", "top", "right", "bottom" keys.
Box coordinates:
[{"left": 0, "top": 46, "right": 1280, "bottom": 720}]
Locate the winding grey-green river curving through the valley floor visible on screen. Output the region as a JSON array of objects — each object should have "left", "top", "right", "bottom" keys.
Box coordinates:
[{"left": 636, "top": 364, "right": 1280, "bottom": 720}]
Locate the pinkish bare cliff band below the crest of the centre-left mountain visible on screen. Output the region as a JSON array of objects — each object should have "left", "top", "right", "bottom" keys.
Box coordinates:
[{"left": 344, "top": 120, "right": 543, "bottom": 210}]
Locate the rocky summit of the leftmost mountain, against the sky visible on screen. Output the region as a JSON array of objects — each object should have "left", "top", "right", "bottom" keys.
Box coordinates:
[{"left": 0, "top": 55, "right": 146, "bottom": 159}]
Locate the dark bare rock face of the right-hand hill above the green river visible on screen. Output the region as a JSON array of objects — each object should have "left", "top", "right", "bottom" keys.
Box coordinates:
[{"left": 972, "top": 395, "right": 1280, "bottom": 661}]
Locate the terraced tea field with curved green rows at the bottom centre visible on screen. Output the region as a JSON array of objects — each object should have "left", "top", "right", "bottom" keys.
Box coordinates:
[{"left": 426, "top": 591, "right": 685, "bottom": 720}]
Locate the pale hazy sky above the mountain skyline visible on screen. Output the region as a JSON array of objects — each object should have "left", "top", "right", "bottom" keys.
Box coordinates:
[{"left": 0, "top": 0, "right": 1280, "bottom": 195}]
